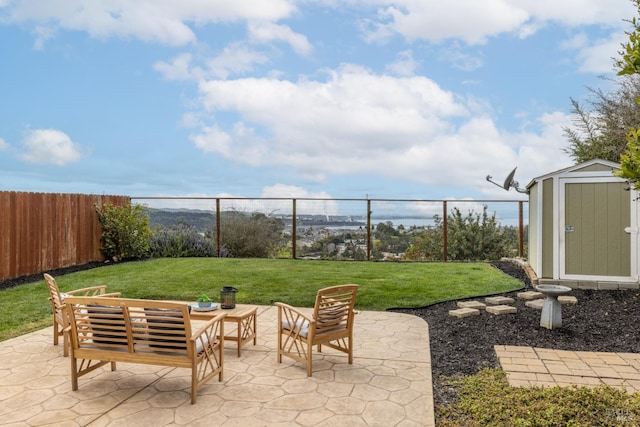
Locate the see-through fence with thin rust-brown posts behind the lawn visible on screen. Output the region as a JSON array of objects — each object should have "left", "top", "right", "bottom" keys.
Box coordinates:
[{"left": 131, "top": 197, "right": 528, "bottom": 261}]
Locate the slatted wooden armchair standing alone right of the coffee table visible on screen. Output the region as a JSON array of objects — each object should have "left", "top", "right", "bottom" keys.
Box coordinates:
[{"left": 275, "top": 285, "right": 358, "bottom": 377}]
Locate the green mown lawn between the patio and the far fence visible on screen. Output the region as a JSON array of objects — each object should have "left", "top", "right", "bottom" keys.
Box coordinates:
[{"left": 0, "top": 258, "right": 522, "bottom": 340}]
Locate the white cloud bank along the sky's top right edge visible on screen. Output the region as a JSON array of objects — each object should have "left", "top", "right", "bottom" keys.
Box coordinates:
[{"left": 360, "top": 0, "right": 636, "bottom": 78}]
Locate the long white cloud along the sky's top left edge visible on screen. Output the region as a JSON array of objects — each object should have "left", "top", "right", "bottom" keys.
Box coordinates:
[{"left": 4, "top": 0, "right": 296, "bottom": 46}]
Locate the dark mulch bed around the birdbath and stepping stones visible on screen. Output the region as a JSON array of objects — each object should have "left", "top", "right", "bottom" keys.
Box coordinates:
[{"left": 394, "top": 261, "right": 640, "bottom": 407}]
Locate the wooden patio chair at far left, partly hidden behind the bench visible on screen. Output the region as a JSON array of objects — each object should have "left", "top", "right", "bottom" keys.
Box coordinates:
[{"left": 44, "top": 273, "right": 120, "bottom": 357}]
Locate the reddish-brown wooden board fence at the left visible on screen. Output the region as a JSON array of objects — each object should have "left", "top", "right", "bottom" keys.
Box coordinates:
[{"left": 0, "top": 191, "right": 130, "bottom": 280}]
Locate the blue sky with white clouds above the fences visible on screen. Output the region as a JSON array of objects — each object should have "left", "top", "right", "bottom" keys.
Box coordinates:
[{"left": 0, "top": 0, "right": 637, "bottom": 207}]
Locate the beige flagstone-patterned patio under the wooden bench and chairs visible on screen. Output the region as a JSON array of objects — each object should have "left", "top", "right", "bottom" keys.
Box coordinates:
[{"left": 0, "top": 306, "right": 435, "bottom": 427}]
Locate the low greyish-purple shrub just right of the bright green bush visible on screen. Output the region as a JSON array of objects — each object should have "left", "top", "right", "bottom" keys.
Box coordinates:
[{"left": 150, "top": 224, "right": 216, "bottom": 258}]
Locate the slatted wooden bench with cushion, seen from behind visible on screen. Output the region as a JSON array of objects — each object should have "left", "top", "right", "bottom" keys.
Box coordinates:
[{"left": 65, "top": 296, "right": 225, "bottom": 403}]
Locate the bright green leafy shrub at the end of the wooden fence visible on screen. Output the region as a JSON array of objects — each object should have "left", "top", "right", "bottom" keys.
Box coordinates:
[{"left": 96, "top": 204, "right": 151, "bottom": 262}]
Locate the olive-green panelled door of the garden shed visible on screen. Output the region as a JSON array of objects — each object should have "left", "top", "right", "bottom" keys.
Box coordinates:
[{"left": 560, "top": 182, "right": 631, "bottom": 278}]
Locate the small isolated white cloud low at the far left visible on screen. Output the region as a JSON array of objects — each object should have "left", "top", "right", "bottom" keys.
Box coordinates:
[{"left": 20, "top": 129, "right": 82, "bottom": 166}]
